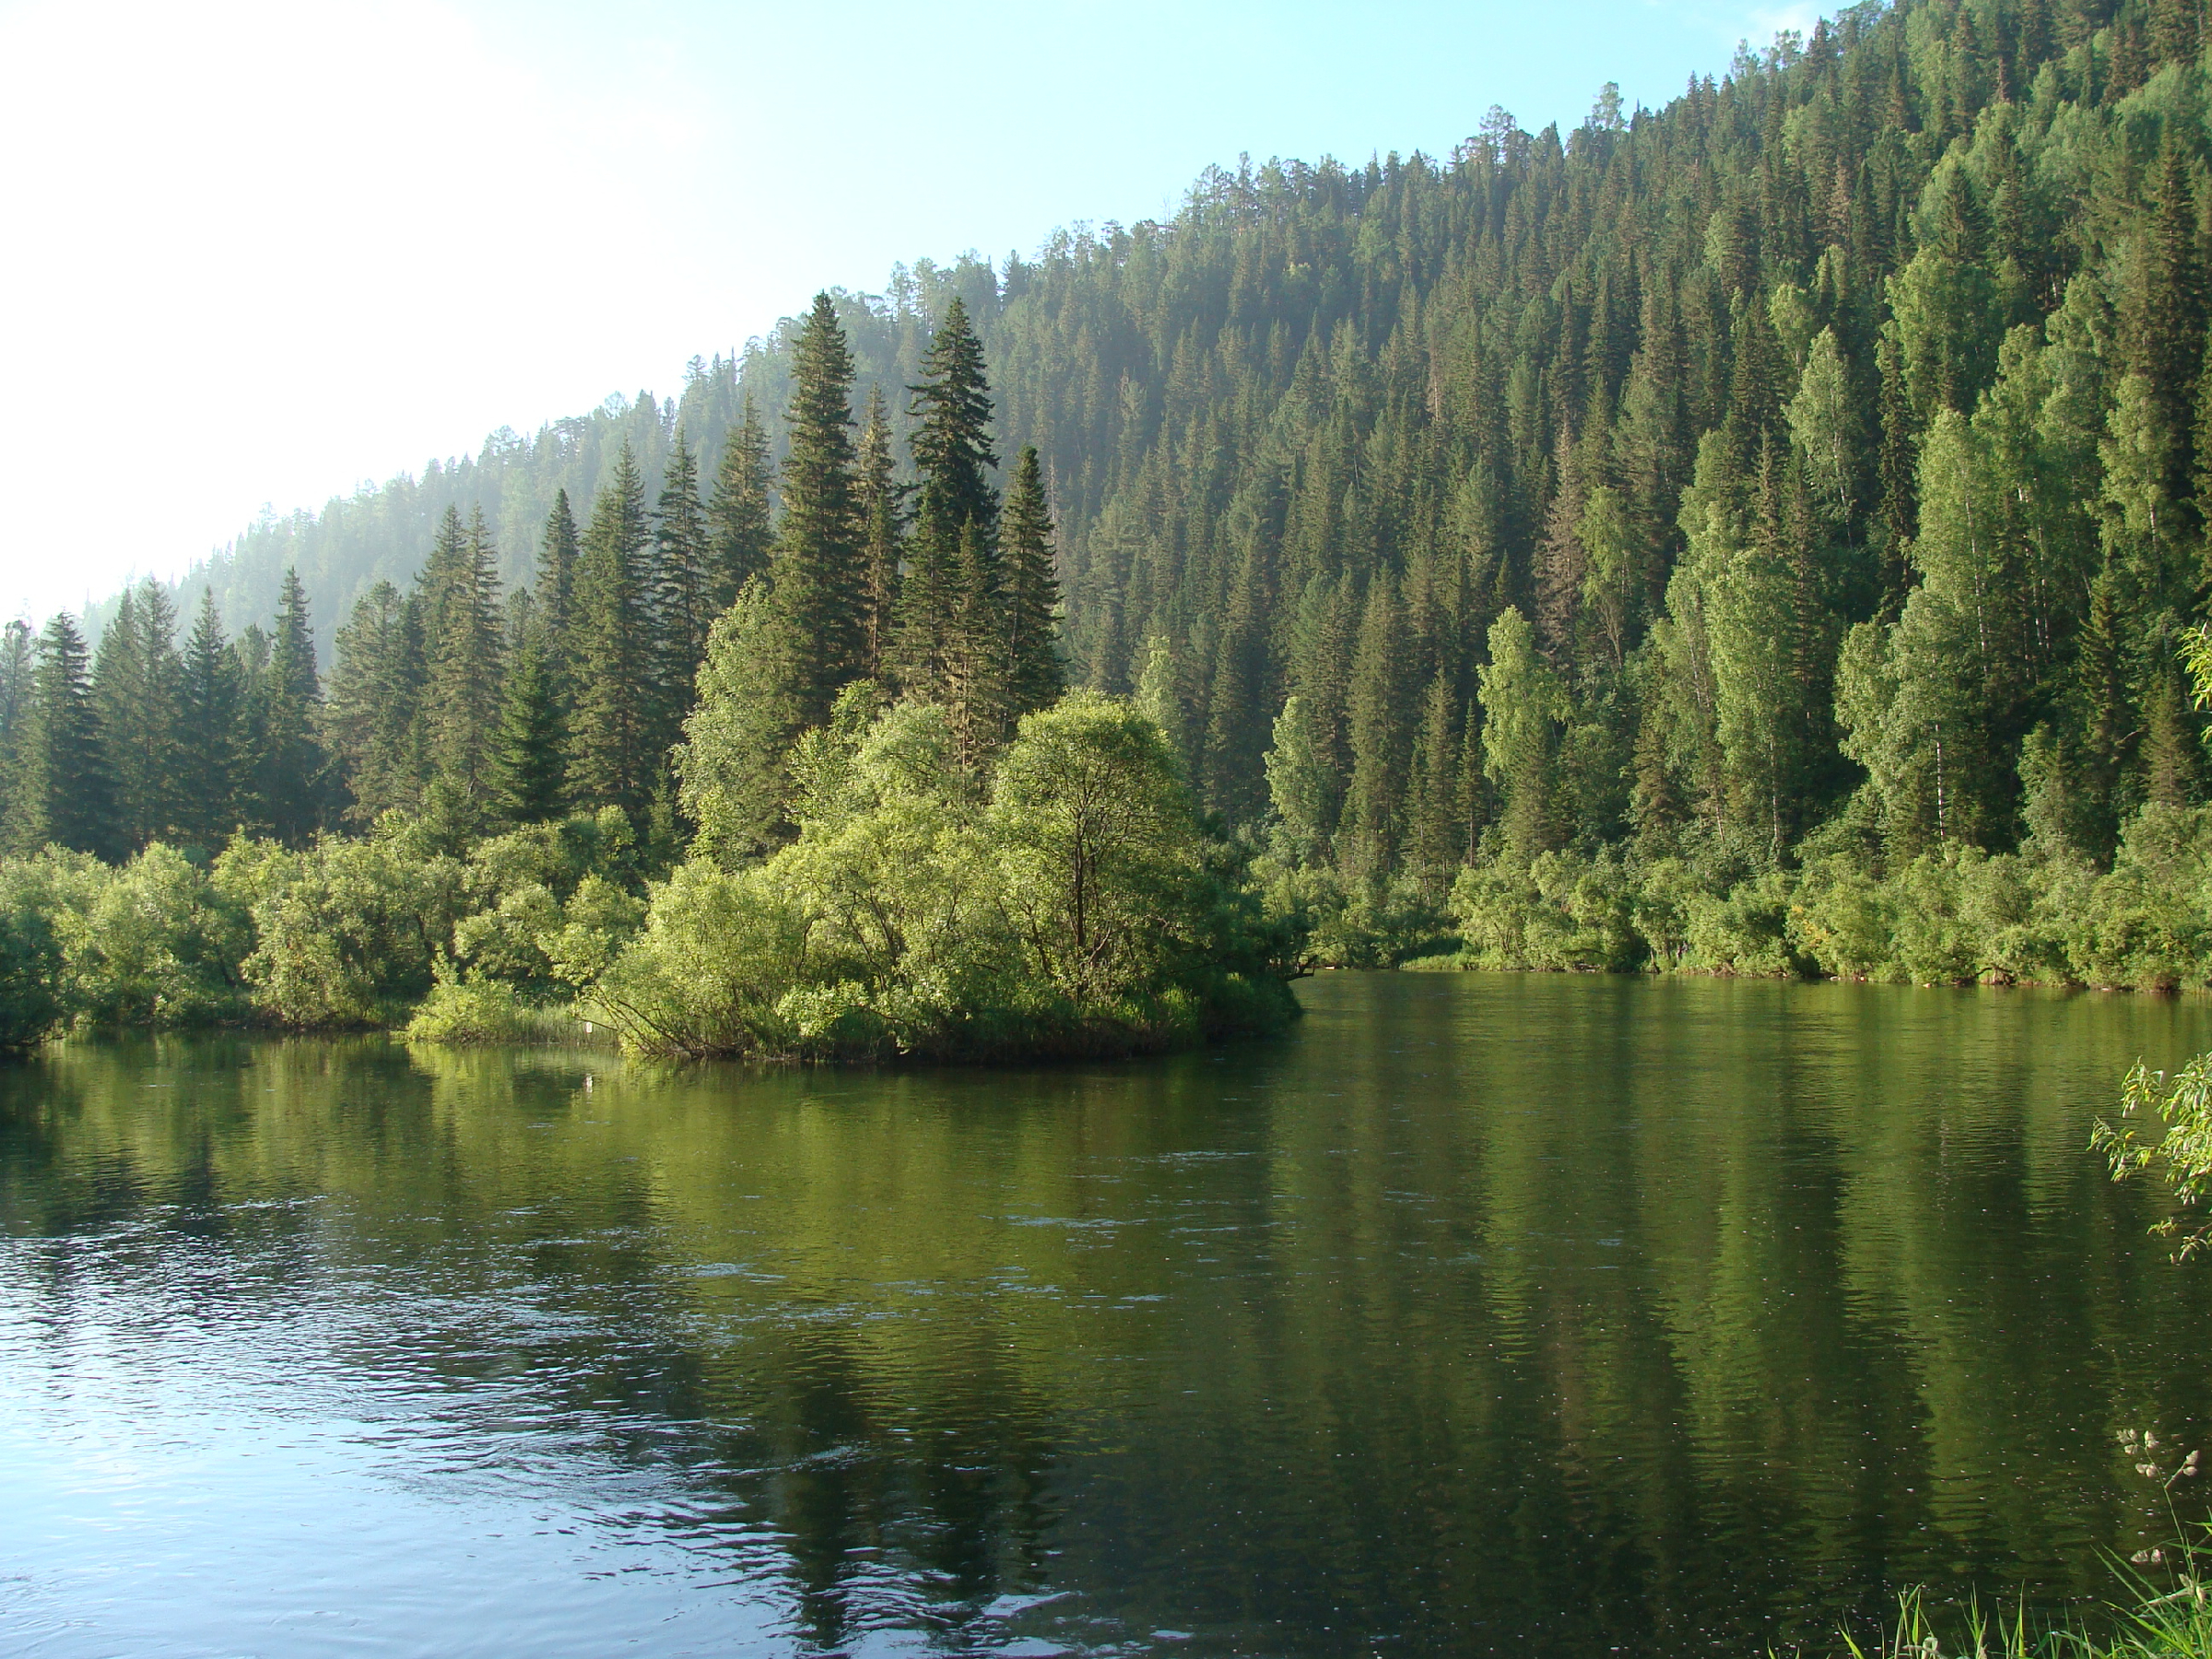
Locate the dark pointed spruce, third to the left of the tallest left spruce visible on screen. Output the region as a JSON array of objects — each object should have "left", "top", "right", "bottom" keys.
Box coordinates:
[{"left": 566, "top": 444, "right": 664, "bottom": 823}]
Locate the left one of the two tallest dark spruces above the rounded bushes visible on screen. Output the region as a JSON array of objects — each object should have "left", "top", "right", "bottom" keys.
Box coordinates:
[{"left": 770, "top": 294, "right": 865, "bottom": 725}]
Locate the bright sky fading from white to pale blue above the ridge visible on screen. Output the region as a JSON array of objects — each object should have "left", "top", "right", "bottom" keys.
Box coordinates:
[{"left": 0, "top": 0, "right": 1814, "bottom": 619}]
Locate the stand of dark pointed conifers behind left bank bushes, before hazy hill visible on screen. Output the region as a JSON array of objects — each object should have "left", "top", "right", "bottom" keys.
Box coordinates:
[{"left": 0, "top": 297, "right": 1062, "bottom": 863}]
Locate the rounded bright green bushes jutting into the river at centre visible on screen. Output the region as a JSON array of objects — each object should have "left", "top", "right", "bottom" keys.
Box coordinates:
[{"left": 588, "top": 684, "right": 1292, "bottom": 1060}]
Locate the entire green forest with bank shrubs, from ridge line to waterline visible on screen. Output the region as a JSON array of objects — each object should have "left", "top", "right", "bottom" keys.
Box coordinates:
[{"left": 13, "top": 0, "right": 2212, "bottom": 1053}]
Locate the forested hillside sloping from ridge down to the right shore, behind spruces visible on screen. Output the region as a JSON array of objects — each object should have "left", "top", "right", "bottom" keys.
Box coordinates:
[{"left": 13, "top": 0, "right": 2212, "bottom": 999}]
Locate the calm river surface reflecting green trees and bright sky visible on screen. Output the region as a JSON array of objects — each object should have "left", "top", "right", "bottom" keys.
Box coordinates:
[{"left": 0, "top": 975, "right": 2212, "bottom": 1657}]
